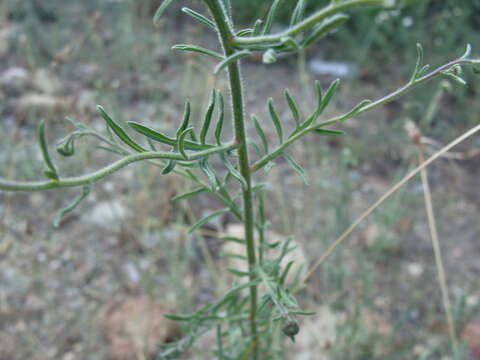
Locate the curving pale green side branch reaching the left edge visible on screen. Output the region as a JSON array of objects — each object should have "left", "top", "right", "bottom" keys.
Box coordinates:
[{"left": 0, "top": 141, "right": 239, "bottom": 191}]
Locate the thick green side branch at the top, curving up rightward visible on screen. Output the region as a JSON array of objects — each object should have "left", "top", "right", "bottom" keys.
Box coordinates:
[{"left": 232, "top": 0, "right": 384, "bottom": 48}]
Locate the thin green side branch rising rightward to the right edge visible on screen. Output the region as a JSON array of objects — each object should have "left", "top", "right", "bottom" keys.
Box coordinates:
[{"left": 251, "top": 59, "right": 478, "bottom": 173}]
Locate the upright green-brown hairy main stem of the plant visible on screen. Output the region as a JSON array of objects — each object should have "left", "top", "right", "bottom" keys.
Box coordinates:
[{"left": 204, "top": 0, "right": 258, "bottom": 359}]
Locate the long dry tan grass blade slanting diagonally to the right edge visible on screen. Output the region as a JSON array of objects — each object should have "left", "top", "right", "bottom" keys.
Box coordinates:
[{"left": 295, "top": 125, "right": 480, "bottom": 290}]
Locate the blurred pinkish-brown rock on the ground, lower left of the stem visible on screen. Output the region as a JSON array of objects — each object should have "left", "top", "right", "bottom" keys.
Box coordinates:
[{"left": 104, "top": 296, "right": 178, "bottom": 360}]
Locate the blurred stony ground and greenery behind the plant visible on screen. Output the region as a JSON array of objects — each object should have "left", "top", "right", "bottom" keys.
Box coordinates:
[{"left": 0, "top": 0, "right": 480, "bottom": 360}]
